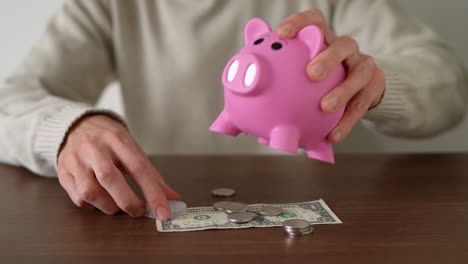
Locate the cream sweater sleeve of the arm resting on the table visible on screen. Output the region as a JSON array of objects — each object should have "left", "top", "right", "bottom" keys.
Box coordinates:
[{"left": 0, "top": 0, "right": 122, "bottom": 176}]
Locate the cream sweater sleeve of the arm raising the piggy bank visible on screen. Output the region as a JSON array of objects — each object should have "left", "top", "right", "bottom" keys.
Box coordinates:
[{"left": 331, "top": 0, "right": 468, "bottom": 138}]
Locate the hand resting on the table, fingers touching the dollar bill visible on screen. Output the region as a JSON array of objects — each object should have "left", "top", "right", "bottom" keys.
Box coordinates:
[{"left": 57, "top": 115, "right": 180, "bottom": 220}]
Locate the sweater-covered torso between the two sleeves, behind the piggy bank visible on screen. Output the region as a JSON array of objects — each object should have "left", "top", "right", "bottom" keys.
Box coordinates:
[{"left": 111, "top": 0, "right": 352, "bottom": 154}]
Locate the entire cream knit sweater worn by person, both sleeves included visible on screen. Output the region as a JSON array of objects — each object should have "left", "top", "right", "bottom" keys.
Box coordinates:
[{"left": 0, "top": 0, "right": 467, "bottom": 176}]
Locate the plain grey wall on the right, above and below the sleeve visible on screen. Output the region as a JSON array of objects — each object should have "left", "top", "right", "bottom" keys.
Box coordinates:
[{"left": 338, "top": 0, "right": 468, "bottom": 152}]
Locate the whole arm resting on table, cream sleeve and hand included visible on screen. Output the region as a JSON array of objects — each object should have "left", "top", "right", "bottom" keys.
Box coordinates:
[{"left": 0, "top": 0, "right": 180, "bottom": 220}]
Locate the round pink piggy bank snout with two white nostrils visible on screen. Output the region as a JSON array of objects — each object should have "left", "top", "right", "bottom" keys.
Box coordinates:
[{"left": 222, "top": 54, "right": 263, "bottom": 94}]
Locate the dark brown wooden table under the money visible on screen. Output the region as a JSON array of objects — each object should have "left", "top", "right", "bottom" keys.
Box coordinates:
[{"left": 0, "top": 154, "right": 468, "bottom": 264}]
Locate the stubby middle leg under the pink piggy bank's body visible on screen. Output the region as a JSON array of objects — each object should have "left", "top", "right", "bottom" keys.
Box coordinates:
[{"left": 269, "top": 126, "right": 300, "bottom": 153}]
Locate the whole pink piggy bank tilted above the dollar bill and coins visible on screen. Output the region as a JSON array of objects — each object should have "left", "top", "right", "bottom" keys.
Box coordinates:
[{"left": 210, "top": 18, "right": 346, "bottom": 163}]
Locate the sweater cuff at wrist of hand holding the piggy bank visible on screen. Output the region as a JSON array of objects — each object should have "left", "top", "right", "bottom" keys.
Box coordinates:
[{"left": 363, "top": 72, "right": 407, "bottom": 122}]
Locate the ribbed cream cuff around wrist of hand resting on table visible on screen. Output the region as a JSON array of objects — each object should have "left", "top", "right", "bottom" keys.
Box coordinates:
[{"left": 34, "top": 104, "right": 125, "bottom": 175}]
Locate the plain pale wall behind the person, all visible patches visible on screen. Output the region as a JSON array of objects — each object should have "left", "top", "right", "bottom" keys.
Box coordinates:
[{"left": 0, "top": 0, "right": 468, "bottom": 152}]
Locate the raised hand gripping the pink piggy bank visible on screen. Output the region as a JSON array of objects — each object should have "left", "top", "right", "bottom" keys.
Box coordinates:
[{"left": 276, "top": 9, "right": 385, "bottom": 144}]
